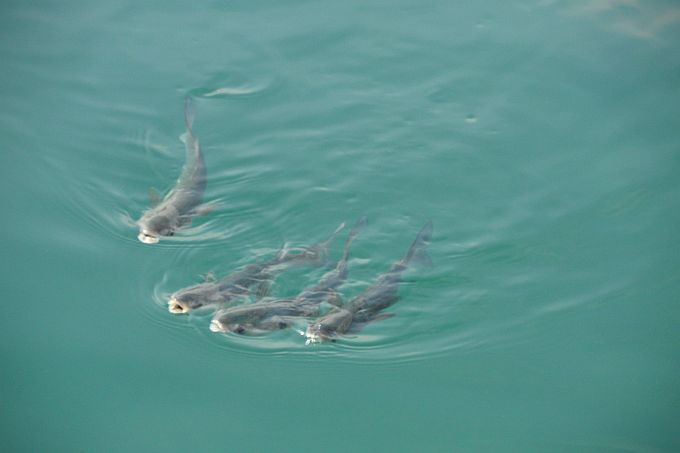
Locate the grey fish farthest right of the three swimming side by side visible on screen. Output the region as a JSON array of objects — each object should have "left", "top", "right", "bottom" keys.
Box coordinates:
[{"left": 304, "top": 221, "right": 433, "bottom": 344}]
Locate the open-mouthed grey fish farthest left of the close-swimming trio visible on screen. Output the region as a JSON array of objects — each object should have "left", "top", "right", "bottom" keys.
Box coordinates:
[{"left": 168, "top": 223, "right": 345, "bottom": 314}]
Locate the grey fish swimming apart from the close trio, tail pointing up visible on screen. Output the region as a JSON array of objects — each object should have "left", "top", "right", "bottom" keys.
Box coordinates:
[{"left": 137, "top": 97, "right": 212, "bottom": 244}]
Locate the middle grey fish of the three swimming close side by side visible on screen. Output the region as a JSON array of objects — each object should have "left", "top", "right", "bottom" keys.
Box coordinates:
[{"left": 210, "top": 217, "right": 366, "bottom": 335}]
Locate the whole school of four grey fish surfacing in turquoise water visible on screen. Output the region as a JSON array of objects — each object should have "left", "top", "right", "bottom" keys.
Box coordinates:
[{"left": 137, "top": 97, "right": 433, "bottom": 344}]
